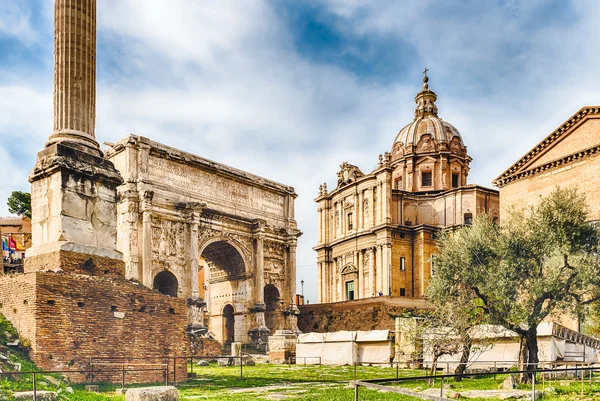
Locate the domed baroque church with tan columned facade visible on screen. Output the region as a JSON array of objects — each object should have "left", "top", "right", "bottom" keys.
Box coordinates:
[{"left": 313, "top": 76, "right": 499, "bottom": 303}]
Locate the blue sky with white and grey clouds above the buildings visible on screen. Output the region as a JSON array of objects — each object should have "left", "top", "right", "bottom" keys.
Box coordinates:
[{"left": 0, "top": 0, "right": 600, "bottom": 302}]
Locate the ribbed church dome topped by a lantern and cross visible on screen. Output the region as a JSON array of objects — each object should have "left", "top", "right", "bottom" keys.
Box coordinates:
[{"left": 392, "top": 75, "right": 467, "bottom": 160}]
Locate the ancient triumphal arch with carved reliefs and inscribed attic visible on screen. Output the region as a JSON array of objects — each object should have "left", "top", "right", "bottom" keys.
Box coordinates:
[{"left": 105, "top": 135, "right": 301, "bottom": 343}]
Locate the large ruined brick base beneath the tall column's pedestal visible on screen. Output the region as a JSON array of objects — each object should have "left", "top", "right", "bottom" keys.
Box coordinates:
[{"left": 0, "top": 272, "right": 189, "bottom": 382}]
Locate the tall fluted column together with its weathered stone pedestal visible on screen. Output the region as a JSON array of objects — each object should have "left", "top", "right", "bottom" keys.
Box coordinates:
[{"left": 25, "top": 0, "right": 125, "bottom": 276}]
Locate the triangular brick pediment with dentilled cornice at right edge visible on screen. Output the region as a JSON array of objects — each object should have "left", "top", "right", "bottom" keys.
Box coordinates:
[{"left": 494, "top": 106, "right": 600, "bottom": 187}]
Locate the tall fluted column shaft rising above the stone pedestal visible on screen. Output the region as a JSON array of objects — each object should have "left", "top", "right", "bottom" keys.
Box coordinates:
[{"left": 47, "top": 0, "right": 99, "bottom": 149}]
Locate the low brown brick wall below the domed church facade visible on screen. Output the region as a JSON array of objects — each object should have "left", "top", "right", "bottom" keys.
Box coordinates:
[{"left": 298, "top": 297, "right": 431, "bottom": 333}]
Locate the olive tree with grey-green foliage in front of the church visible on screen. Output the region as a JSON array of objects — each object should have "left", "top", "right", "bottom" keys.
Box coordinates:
[{"left": 429, "top": 188, "right": 600, "bottom": 376}]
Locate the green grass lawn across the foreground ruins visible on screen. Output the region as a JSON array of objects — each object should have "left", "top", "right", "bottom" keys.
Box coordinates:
[{"left": 0, "top": 364, "right": 600, "bottom": 401}]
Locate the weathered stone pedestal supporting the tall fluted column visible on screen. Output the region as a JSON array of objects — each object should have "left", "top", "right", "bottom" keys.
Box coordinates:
[{"left": 25, "top": 142, "right": 125, "bottom": 276}]
